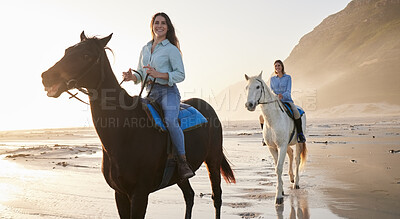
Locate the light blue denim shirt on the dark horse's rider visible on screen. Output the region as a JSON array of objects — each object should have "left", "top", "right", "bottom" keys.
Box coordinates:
[{"left": 134, "top": 39, "right": 185, "bottom": 86}]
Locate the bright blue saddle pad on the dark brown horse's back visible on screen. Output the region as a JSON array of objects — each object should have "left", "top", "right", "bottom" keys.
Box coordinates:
[{"left": 146, "top": 103, "right": 208, "bottom": 131}]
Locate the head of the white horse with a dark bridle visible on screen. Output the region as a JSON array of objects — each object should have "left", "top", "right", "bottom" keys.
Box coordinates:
[{"left": 244, "top": 71, "right": 277, "bottom": 111}]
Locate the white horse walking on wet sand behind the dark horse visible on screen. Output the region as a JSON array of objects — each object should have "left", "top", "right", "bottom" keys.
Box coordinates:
[{"left": 245, "top": 72, "right": 307, "bottom": 205}]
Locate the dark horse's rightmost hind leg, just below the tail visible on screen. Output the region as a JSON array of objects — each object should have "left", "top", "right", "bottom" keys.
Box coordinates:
[{"left": 206, "top": 161, "right": 222, "bottom": 219}]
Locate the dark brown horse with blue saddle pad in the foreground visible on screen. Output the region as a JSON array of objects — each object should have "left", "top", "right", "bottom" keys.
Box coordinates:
[{"left": 42, "top": 32, "right": 235, "bottom": 218}]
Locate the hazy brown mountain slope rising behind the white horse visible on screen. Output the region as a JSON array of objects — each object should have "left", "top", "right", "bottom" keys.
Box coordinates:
[{"left": 284, "top": 0, "right": 400, "bottom": 109}]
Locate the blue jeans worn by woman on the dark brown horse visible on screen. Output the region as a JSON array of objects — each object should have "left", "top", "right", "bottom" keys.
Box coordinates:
[{"left": 146, "top": 84, "right": 185, "bottom": 155}]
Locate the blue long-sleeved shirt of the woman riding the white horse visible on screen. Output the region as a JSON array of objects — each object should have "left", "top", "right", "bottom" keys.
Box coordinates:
[{"left": 270, "top": 74, "right": 293, "bottom": 102}]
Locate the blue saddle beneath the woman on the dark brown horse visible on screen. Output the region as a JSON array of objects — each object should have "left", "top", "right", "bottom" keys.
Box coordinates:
[{"left": 142, "top": 98, "right": 208, "bottom": 132}]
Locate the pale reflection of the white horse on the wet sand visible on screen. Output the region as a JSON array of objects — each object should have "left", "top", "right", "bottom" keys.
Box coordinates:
[{"left": 275, "top": 190, "right": 310, "bottom": 219}]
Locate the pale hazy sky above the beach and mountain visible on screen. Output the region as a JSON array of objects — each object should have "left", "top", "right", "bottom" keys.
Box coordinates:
[{"left": 0, "top": 0, "right": 350, "bottom": 130}]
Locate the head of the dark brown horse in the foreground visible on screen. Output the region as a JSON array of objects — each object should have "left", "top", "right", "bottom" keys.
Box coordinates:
[{"left": 42, "top": 32, "right": 112, "bottom": 98}]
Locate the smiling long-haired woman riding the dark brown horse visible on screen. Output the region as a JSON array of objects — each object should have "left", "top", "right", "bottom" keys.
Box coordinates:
[{"left": 123, "top": 12, "right": 194, "bottom": 179}]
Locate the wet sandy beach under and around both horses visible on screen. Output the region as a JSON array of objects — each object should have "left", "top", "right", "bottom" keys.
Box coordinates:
[{"left": 0, "top": 117, "right": 400, "bottom": 219}]
